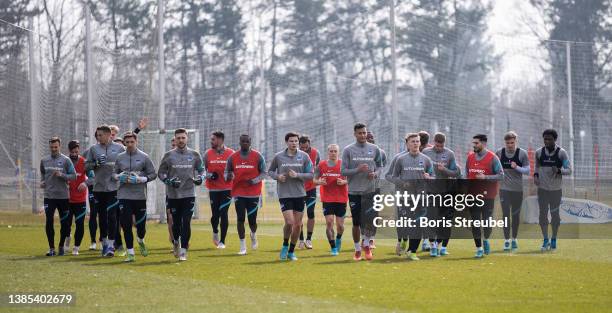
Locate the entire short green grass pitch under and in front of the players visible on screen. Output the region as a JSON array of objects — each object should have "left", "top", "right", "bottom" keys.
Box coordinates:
[{"left": 0, "top": 216, "right": 612, "bottom": 313}]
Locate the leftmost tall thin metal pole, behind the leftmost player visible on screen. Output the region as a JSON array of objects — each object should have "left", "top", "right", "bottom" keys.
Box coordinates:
[{"left": 28, "top": 17, "right": 38, "bottom": 214}]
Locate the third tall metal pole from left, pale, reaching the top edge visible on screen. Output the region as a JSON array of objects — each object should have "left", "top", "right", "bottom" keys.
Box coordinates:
[{"left": 156, "top": 0, "right": 167, "bottom": 223}]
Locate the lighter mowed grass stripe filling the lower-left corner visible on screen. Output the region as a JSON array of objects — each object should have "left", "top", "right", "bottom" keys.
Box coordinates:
[{"left": 0, "top": 254, "right": 394, "bottom": 313}]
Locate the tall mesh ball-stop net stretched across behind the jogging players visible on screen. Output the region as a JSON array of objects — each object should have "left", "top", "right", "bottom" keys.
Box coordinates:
[{"left": 0, "top": 1, "right": 612, "bottom": 224}]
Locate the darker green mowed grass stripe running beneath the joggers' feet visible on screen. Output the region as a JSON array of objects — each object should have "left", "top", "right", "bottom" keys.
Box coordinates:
[{"left": 0, "top": 224, "right": 612, "bottom": 312}]
